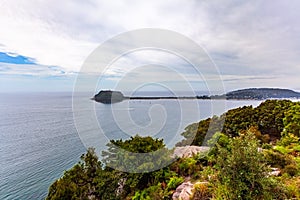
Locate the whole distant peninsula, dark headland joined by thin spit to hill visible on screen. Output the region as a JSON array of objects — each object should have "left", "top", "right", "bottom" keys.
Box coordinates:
[{"left": 92, "top": 88, "right": 300, "bottom": 104}]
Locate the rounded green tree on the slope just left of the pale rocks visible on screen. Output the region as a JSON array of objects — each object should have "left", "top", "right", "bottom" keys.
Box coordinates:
[{"left": 102, "top": 135, "right": 172, "bottom": 196}]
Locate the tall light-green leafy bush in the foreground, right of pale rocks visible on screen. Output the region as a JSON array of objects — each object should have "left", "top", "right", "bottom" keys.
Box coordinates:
[{"left": 216, "top": 134, "right": 284, "bottom": 199}]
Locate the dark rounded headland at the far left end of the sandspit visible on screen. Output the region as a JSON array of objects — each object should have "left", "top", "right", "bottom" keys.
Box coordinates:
[{"left": 93, "top": 90, "right": 124, "bottom": 104}]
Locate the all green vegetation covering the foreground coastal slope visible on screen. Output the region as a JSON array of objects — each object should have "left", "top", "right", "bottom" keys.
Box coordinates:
[{"left": 47, "top": 100, "right": 300, "bottom": 200}]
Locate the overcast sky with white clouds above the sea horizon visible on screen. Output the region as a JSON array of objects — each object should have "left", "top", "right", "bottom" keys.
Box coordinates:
[{"left": 0, "top": 0, "right": 300, "bottom": 93}]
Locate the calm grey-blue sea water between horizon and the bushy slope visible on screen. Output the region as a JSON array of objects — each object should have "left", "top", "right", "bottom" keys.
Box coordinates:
[{"left": 0, "top": 93, "right": 260, "bottom": 200}]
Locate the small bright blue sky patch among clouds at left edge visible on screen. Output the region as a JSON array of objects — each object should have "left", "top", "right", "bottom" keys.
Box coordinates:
[{"left": 0, "top": 52, "right": 36, "bottom": 64}]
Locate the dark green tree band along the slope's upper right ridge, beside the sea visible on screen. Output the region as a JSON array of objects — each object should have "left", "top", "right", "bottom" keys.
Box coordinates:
[{"left": 177, "top": 100, "right": 300, "bottom": 146}]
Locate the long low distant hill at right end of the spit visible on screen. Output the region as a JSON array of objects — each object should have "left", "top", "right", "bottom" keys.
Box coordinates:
[{"left": 226, "top": 88, "right": 300, "bottom": 100}]
